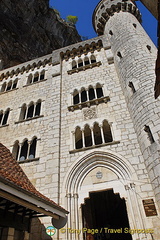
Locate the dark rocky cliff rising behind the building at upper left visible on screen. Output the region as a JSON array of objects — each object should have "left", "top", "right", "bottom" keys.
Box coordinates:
[{"left": 0, "top": 0, "right": 81, "bottom": 69}]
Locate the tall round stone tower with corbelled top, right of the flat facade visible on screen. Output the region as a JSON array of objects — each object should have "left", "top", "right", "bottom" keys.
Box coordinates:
[{"left": 93, "top": 0, "right": 160, "bottom": 206}]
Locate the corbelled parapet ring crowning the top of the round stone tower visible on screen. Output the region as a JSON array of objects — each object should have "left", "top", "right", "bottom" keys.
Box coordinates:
[{"left": 93, "top": 0, "right": 141, "bottom": 35}]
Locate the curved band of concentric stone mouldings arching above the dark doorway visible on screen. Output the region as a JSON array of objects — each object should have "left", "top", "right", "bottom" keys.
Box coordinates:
[{"left": 63, "top": 151, "right": 137, "bottom": 194}]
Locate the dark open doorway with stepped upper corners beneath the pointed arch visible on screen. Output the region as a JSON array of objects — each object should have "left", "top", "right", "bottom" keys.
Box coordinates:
[{"left": 81, "top": 189, "right": 132, "bottom": 240}]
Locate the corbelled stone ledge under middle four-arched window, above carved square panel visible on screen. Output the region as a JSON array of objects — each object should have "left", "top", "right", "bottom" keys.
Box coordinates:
[{"left": 68, "top": 96, "right": 110, "bottom": 112}]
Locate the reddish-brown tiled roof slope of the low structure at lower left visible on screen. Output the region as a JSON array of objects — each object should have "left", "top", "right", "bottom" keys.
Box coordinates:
[{"left": 0, "top": 143, "right": 68, "bottom": 216}]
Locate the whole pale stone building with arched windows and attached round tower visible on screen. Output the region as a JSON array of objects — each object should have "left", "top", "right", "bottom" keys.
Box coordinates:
[{"left": 0, "top": 0, "right": 160, "bottom": 240}]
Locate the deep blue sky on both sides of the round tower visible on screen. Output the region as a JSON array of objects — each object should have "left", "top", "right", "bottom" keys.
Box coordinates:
[{"left": 50, "top": 0, "right": 157, "bottom": 45}]
